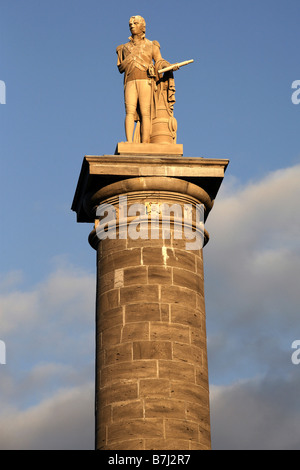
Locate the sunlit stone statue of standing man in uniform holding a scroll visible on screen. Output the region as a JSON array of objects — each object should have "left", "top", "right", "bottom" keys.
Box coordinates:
[{"left": 117, "top": 16, "right": 193, "bottom": 143}]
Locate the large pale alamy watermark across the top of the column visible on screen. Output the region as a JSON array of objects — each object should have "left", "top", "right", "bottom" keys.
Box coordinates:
[{"left": 96, "top": 196, "right": 204, "bottom": 250}]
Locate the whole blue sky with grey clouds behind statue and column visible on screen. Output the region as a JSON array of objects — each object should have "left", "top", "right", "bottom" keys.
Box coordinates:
[{"left": 0, "top": 0, "right": 300, "bottom": 449}]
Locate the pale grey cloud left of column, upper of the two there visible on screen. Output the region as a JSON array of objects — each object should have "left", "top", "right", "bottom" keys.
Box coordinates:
[{"left": 0, "top": 267, "right": 95, "bottom": 336}]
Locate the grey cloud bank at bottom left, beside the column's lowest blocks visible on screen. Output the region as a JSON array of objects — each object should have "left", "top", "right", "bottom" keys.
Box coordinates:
[{"left": 0, "top": 383, "right": 94, "bottom": 450}]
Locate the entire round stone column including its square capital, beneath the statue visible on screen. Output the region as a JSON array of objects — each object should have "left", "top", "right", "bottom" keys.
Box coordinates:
[{"left": 72, "top": 152, "right": 228, "bottom": 450}]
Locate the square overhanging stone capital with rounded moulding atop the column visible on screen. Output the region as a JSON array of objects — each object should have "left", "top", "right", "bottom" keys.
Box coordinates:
[{"left": 72, "top": 155, "right": 229, "bottom": 222}]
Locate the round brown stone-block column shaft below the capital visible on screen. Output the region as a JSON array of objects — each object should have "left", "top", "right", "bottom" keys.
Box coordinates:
[{"left": 93, "top": 185, "right": 210, "bottom": 450}]
